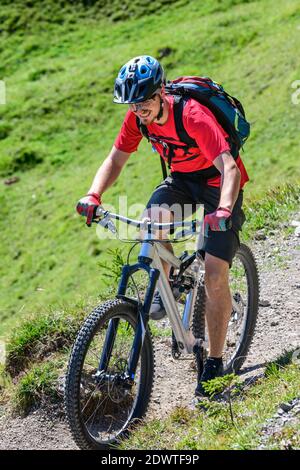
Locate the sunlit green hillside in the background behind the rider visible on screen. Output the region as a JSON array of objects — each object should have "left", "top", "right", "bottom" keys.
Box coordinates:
[{"left": 0, "top": 0, "right": 300, "bottom": 334}]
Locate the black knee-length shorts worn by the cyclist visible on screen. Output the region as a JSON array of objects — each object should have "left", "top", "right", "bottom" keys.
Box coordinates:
[{"left": 147, "top": 172, "right": 245, "bottom": 266}]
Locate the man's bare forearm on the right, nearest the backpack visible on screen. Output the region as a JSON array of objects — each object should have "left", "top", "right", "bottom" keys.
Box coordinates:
[{"left": 214, "top": 152, "right": 241, "bottom": 211}]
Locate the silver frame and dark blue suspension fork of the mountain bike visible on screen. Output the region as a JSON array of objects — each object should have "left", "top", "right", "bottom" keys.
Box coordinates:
[{"left": 98, "top": 209, "right": 204, "bottom": 381}]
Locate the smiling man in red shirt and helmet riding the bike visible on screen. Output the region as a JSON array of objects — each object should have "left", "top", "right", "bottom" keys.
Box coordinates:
[{"left": 77, "top": 56, "right": 249, "bottom": 396}]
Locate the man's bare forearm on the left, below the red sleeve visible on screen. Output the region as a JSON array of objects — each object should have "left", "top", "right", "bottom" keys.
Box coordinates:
[{"left": 89, "top": 146, "right": 130, "bottom": 196}]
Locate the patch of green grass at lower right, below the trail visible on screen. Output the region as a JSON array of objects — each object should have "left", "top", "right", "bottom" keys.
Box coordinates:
[{"left": 121, "top": 358, "right": 300, "bottom": 450}]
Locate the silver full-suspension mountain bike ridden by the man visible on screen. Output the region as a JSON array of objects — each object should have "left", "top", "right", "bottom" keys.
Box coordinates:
[{"left": 65, "top": 207, "right": 259, "bottom": 449}]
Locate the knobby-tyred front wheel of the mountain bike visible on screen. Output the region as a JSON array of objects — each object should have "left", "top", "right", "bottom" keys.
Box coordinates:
[{"left": 65, "top": 300, "right": 154, "bottom": 450}]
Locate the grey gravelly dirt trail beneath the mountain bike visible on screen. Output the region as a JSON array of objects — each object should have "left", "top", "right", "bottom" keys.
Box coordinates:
[{"left": 0, "top": 222, "right": 300, "bottom": 449}]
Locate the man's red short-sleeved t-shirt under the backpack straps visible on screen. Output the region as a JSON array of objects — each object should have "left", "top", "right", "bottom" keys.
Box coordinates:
[{"left": 115, "top": 95, "right": 249, "bottom": 188}]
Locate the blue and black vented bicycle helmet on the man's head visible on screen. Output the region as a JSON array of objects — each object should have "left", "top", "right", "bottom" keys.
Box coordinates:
[{"left": 114, "top": 55, "right": 164, "bottom": 104}]
